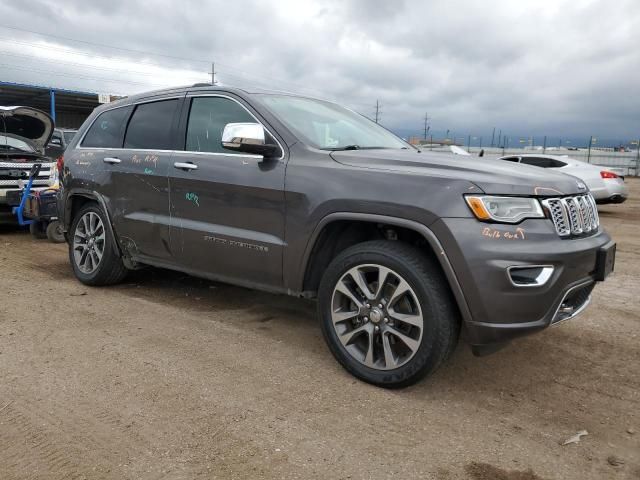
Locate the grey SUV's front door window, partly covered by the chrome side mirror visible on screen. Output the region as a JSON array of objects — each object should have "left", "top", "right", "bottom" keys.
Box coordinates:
[{"left": 185, "top": 97, "right": 256, "bottom": 153}]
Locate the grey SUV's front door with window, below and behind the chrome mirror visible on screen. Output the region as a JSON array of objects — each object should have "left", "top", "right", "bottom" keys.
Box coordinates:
[{"left": 169, "top": 94, "right": 285, "bottom": 288}]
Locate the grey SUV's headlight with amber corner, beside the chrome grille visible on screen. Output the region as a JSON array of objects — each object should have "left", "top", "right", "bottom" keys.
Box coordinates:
[{"left": 464, "top": 195, "right": 544, "bottom": 223}]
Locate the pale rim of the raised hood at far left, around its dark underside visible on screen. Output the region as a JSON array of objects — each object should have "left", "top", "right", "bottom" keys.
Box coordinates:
[{"left": 0, "top": 107, "right": 54, "bottom": 150}]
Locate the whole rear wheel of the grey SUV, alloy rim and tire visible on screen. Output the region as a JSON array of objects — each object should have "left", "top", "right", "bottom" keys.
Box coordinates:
[{"left": 69, "top": 204, "right": 127, "bottom": 285}]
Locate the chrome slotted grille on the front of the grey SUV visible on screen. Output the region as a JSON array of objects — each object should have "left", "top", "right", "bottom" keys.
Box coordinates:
[{"left": 542, "top": 194, "right": 600, "bottom": 237}]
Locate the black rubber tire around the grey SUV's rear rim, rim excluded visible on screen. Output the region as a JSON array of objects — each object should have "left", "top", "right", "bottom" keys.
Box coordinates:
[{"left": 69, "top": 203, "right": 128, "bottom": 286}]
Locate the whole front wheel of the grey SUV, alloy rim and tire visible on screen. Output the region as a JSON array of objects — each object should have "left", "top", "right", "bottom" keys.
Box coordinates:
[{"left": 318, "top": 241, "right": 460, "bottom": 388}]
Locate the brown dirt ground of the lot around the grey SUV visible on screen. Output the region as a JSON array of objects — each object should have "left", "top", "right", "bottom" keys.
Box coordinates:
[{"left": 0, "top": 179, "right": 640, "bottom": 480}]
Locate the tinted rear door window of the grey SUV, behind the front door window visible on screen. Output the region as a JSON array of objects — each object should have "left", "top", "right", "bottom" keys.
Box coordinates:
[{"left": 124, "top": 100, "right": 178, "bottom": 150}]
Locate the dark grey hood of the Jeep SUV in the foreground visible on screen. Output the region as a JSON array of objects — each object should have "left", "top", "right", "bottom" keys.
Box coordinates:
[{"left": 331, "top": 149, "right": 586, "bottom": 197}]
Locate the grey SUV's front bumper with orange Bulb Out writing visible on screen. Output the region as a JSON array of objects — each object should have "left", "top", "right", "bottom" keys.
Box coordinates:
[{"left": 431, "top": 218, "right": 612, "bottom": 348}]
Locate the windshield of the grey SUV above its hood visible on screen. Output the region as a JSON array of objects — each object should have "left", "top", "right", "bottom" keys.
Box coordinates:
[{"left": 260, "top": 94, "right": 409, "bottom": 150}]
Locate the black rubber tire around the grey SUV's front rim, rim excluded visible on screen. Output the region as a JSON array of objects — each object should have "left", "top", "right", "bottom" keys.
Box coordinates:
[{"left": 318, "top": 240, "right": 460, "bottom": 388}]
